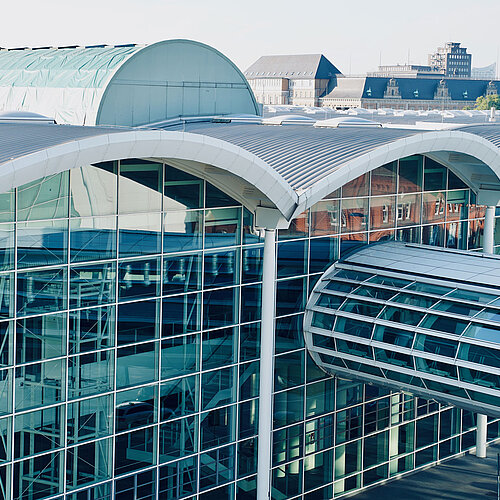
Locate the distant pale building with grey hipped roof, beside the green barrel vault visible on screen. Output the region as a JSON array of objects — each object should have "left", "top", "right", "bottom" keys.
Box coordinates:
[{"left": 245, "top": 54, "right": 341, "bottom": 106}]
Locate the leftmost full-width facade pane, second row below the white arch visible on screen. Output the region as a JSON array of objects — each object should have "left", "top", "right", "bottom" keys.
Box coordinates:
[{"left": 17, "top": 220, "right": 68, "bottom": 268}]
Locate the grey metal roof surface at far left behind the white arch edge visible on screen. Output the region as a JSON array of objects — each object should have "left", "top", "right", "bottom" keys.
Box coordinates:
[{"left": 0, "top": 123, "right": 127, "bottom": 165}]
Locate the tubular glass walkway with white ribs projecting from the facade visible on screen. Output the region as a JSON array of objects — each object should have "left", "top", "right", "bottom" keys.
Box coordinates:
[{"left": 304, "top": 242, "right": 500, "bottom": 417}]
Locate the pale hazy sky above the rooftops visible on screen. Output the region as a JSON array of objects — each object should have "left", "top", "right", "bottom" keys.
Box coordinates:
[{"left": 0, "top": 0, "right": 500, "bottom": 74}]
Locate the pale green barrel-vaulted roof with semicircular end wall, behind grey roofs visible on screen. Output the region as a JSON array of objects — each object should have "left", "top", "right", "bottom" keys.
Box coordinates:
[{"left": 0, "top": 40, "right": 259, "bottom": 126}]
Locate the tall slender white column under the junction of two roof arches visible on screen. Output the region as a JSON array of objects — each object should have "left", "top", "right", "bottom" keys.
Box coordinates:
[{"left": 257, "top": 229, "right": 276, "bottom": 500}]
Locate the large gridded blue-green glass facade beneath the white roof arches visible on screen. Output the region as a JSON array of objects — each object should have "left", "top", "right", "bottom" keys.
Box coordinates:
[{"left": 0, "top": 157, "right": 498, "bottom": 500}]
